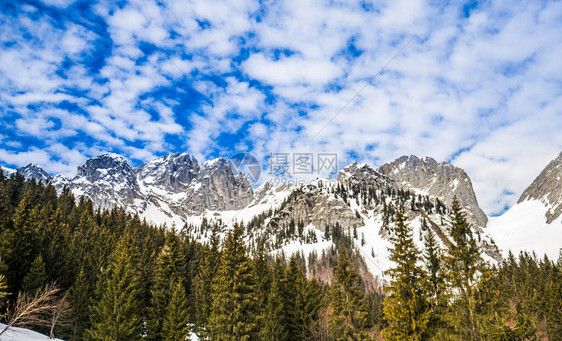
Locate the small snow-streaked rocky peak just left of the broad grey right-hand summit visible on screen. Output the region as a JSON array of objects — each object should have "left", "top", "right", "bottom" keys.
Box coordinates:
[{"left": 337, "top": 162, "right": 396, "bottom": 189}]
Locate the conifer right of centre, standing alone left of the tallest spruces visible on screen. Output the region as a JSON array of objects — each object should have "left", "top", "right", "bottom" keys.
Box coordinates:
[{"left": 330, "top": 249, "right": 367, "bottom": 341}]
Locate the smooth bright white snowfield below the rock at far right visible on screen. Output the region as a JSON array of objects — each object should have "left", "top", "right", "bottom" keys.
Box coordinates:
[{"left": 486, "top": 200, "right": 562, "bottom": 260}]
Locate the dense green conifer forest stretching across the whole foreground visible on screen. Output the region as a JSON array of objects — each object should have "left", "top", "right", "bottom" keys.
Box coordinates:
[{"left": 0, "top": 173, "right": 562, "bottom": 340}]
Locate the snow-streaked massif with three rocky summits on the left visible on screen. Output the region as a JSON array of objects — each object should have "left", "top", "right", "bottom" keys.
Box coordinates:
[{"left": 52, "top": 153, "right": 253, "bottom": 225}]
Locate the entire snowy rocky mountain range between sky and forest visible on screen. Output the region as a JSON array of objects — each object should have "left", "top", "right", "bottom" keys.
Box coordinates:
[{"left": 3, "top": 153, "right": 562, "bottom": 277}]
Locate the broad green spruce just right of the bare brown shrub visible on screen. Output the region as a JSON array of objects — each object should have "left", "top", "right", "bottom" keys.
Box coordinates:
[{"left": 88, "top": 235, "right": 142, "bottom": 340}]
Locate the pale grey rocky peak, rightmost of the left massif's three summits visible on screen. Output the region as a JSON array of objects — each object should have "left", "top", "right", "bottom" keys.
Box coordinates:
[{"left": 182, "top": 158, "right": 254, "bottom": 213}]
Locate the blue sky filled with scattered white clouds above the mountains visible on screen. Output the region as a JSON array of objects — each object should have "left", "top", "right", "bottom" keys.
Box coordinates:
[{"left": 0, "top": 0, "right": 562, "bottom": 215}]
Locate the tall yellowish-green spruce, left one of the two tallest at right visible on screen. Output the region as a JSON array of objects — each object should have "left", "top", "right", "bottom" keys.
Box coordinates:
[{"left": 383, "top": 210, "right": 431, "bottom": 340}]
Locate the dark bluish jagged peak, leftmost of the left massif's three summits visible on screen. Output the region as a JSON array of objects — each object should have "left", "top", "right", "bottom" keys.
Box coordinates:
[{"left": 66, "top": 154, "right": 142, "bottom": 209}]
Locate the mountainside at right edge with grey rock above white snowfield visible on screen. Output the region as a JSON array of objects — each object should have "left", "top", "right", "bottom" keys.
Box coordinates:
[{"left": 488, "top": 153, "right": 562, "bottom": 259}]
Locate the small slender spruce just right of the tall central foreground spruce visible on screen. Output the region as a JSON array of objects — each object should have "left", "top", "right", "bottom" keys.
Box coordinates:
[{"left": 259, "top": 274, "right": 289, "bottom": 341}]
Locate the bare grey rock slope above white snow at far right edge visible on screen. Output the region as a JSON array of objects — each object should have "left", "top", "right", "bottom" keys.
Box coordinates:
[{"left": 517, "top": 152, "right": 562, "bottom": 224}]
